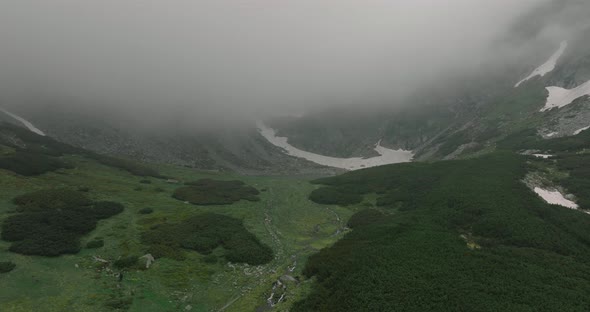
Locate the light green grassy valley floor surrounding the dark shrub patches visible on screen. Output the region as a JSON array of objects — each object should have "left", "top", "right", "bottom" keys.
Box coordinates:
[{"left": 0, "top": 156, "right": 354, "bottom": 312}]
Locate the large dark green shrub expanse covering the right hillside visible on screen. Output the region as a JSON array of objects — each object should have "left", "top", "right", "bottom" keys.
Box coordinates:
[{"left": 293, "top": 153, "right": 590, "bottom": 311}]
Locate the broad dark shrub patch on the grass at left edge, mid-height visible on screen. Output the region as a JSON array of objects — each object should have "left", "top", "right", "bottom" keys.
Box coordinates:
[{"left": 1, "top": 189, "right": 123, "bottom": 256}]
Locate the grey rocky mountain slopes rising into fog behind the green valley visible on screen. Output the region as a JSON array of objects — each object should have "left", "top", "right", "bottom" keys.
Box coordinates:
[{"left": 0, "top": 0, "right": 590, "bottom": 174}]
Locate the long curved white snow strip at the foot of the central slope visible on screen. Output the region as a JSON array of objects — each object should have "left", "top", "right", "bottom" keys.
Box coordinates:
[{"left": 257, "top": 122, "right": 414, "bottom": 170}]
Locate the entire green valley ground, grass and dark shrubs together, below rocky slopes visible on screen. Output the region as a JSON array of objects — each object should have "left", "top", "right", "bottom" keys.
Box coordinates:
[{"left": 0, "top": 121, "right": 590, "bottom": 311}]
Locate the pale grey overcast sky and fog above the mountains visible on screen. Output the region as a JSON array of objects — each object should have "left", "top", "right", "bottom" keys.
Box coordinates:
[{"left": 0, "top": 0, "right": 547, "bottom": 127}]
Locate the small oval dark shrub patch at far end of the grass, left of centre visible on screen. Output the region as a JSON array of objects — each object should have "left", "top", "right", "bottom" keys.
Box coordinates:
[{"left": 172, "top": 179, "right": 260, "bottom": 205}]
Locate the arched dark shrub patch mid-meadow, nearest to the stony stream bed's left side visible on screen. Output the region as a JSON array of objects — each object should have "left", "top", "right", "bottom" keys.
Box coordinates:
[{"left": 142, "top": 213, "right": 273, "bottom": 265}]
